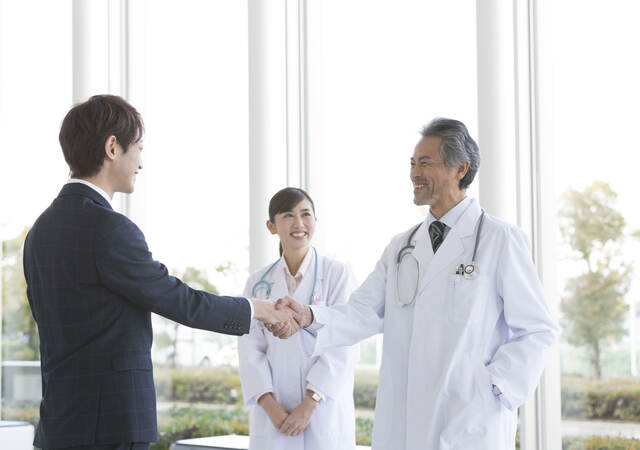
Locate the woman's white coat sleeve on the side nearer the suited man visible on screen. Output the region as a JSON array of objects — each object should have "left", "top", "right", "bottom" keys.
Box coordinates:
[{"left": 238, "top": 277, "right": 273, "bottom": 405}]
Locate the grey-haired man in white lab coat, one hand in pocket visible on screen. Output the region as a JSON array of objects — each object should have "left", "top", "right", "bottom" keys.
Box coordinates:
[{"left": 273, "top": 119, "right": 558, "bottom": 450}]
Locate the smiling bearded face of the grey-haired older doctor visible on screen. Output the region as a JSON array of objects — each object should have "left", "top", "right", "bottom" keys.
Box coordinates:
[{"left": 410, "top": 136, "right": 468, "bottom": 212}]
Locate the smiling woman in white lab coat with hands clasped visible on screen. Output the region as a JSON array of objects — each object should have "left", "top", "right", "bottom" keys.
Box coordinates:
[{"left": 238, "top": 188, "right": 359, "bottom": 450}]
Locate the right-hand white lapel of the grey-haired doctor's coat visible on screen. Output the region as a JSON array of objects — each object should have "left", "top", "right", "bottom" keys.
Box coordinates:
[{"left": 418, "top": 200, "right": 480, "bottom": 294}]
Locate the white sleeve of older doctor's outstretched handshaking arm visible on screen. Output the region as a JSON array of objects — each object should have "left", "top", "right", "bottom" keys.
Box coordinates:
[{"left": 309, "top": 245, "right": 392, "bottom": 356}]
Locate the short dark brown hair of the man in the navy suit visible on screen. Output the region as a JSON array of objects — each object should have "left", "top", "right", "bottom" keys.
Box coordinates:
[{"left": 58, "top": 95, "right": 144, "bottom": 177}]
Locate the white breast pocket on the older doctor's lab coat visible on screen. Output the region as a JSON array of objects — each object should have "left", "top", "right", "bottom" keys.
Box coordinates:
[{"left": 448, "top": 274, "right": 490, "bottom": 323}]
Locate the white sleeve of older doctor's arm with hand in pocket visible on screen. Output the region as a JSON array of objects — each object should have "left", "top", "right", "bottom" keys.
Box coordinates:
[{"left": 487, "top": 228, "right": 558, "bottom": 410}]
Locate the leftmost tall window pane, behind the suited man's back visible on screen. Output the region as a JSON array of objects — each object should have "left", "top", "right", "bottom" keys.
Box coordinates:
[{"left": 0, "top": 0, "right": 71, "bottom": 426}]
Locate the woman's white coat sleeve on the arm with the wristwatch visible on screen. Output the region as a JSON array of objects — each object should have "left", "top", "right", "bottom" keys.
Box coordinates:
[{"left": 306, "top": 265, "right": 360, "bottom": 399}]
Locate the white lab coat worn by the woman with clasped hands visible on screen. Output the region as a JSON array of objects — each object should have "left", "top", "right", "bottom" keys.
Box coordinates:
[{"left": 238, "top": 250, "right": 359, "bottom": 450}]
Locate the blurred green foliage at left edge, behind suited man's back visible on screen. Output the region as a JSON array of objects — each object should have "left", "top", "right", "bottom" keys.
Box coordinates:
[{"left": 0, "top": 228, "right": 40, "bottom": 361}]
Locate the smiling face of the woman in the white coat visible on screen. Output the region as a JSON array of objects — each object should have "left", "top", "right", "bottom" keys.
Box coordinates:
[{"left": 267, "top": 199, "right": 316, "bottom": 253}]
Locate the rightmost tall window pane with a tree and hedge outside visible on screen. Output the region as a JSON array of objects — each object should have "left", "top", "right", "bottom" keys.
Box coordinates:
[{"left": 541, "top": 0, "right": 640, "bottom": 448}]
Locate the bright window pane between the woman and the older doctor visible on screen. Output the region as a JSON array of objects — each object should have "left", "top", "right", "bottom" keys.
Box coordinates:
[{"left": 307, "top": 0, "right": 477, "bottom": 370}]
